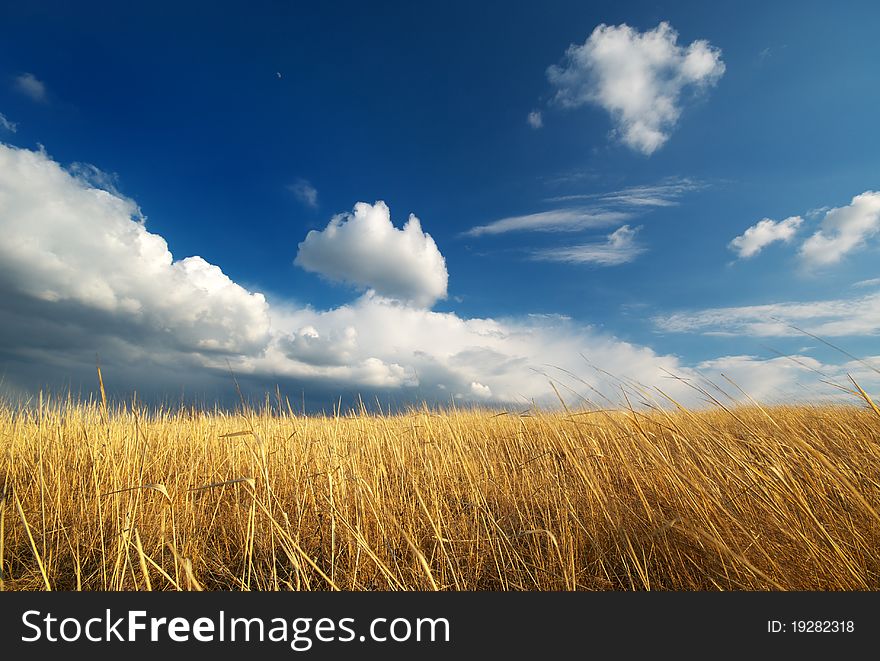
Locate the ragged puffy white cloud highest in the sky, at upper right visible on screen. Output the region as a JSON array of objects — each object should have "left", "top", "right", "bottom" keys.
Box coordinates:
[{"left": 547, "top": 22, "right": 725, "bottom": 155}]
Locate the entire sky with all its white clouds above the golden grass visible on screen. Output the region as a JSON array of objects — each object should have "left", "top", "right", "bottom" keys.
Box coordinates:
[{"left": 0, "top": 2, "right": 880, "bottom": 405}]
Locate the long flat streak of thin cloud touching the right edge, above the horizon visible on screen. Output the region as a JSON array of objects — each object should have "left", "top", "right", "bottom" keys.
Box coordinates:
[{"left": 654, "top": 293, "right": 880, "bottom": 337}]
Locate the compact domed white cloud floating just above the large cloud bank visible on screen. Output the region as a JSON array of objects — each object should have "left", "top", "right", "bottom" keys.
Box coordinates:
[{"left": 295, "top": 201, "right": 449, "bottom": 307}]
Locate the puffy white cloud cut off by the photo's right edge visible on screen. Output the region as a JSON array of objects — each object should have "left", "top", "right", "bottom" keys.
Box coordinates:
[{"left": 800, "top": 191, "right": 880, "bottom": 266}]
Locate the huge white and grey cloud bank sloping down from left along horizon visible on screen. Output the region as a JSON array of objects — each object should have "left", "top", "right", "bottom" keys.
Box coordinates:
[{"left": 0, "top": 145, "right": 872, "bottom": 406}]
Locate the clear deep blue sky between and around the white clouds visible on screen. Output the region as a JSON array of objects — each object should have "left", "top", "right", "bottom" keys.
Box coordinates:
[{"left": 0, "top": 2, "right": 880, "bottom": 361}]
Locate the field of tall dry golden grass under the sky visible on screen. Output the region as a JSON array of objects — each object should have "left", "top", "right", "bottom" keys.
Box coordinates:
[{"left": 0, "top": 386, "right": 880, "bottom": 590}]
